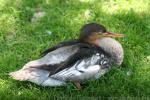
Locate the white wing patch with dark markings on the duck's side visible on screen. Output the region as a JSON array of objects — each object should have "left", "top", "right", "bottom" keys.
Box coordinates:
[{"left": 51, "top": 54, "right": 109, "bottom": 81}]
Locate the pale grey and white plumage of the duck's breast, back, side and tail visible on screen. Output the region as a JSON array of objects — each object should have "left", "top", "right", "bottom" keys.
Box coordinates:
[{"left": 10, "top": 38, "right": 124, "bottom": 86}]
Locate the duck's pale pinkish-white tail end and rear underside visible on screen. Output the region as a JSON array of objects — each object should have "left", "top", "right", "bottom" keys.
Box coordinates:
[{"left": 9, "top": 68, "right": 65, "bottom": 86}]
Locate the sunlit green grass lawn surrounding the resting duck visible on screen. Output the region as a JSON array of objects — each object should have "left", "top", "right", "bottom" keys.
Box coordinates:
[{"left": 0, "top": 0, "right": 150, "bottom": 100}]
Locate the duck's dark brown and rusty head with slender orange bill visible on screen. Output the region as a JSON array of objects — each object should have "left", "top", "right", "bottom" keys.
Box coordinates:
[{"left": 79, "top": 23, "right": 124, "bottom": 45}]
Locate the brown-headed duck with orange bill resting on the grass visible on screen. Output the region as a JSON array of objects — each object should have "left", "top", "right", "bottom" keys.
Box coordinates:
[{"left": 9, "top": 23, "right": 124, "bottom": 90}]
